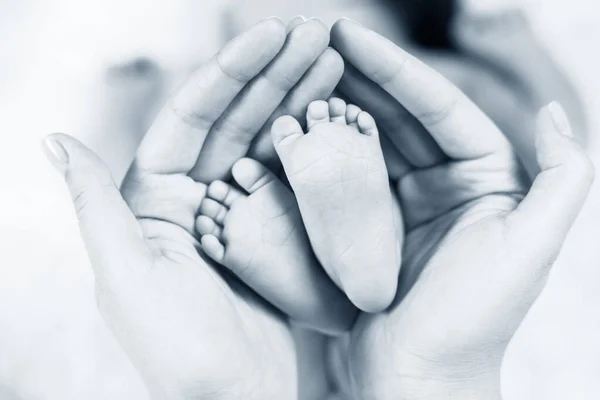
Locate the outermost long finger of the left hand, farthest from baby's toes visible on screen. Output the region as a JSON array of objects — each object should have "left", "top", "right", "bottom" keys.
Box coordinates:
[{"left": 134, "top": 18, "right": 285, "bottom": 174}]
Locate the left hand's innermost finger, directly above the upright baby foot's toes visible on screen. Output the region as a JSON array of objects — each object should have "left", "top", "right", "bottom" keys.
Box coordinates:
[{"left": 248, "top": 48, "right": 344, "bottom": 172}]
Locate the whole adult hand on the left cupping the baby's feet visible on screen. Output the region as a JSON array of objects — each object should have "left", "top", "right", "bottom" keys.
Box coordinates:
[{"left": 45, "top": 19, "right": 343, "bottom": 399}]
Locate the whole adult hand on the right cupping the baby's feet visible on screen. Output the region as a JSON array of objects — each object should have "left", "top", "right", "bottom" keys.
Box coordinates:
[{"left": 331, "top": 20, "right": 593, "bottom": 400}]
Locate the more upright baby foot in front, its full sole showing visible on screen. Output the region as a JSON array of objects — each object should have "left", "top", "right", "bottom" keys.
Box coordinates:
[{"left": 271, "top": 98, "right": 400, "bottom": 312}]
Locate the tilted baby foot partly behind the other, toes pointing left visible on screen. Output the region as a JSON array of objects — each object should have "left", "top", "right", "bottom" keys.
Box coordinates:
[{"left": 196, "top": 158, "right": 357, "bottom": 333}]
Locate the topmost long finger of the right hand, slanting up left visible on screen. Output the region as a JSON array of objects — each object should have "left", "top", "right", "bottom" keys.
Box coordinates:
[{"left": 331, "top": 19, "right": 510, "bottom": 159}]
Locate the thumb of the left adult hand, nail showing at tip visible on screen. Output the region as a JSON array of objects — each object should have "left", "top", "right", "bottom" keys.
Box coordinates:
[{"left": 43, "top": 133, "right": 147, "bottom": 278}]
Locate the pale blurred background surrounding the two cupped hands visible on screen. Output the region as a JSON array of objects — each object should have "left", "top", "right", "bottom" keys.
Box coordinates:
[{"left": 0, "top": 0, "right": 600, "bottom": 400}]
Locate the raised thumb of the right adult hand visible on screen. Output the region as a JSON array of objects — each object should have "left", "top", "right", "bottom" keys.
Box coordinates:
[{"left": 506, "top": 103, "right": 594, "bottom": 255}]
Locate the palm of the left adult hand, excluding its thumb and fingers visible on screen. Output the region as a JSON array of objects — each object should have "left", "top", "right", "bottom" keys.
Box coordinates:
[{"left": 97, "top": 214, "right": 296, "bottom": 399}]
